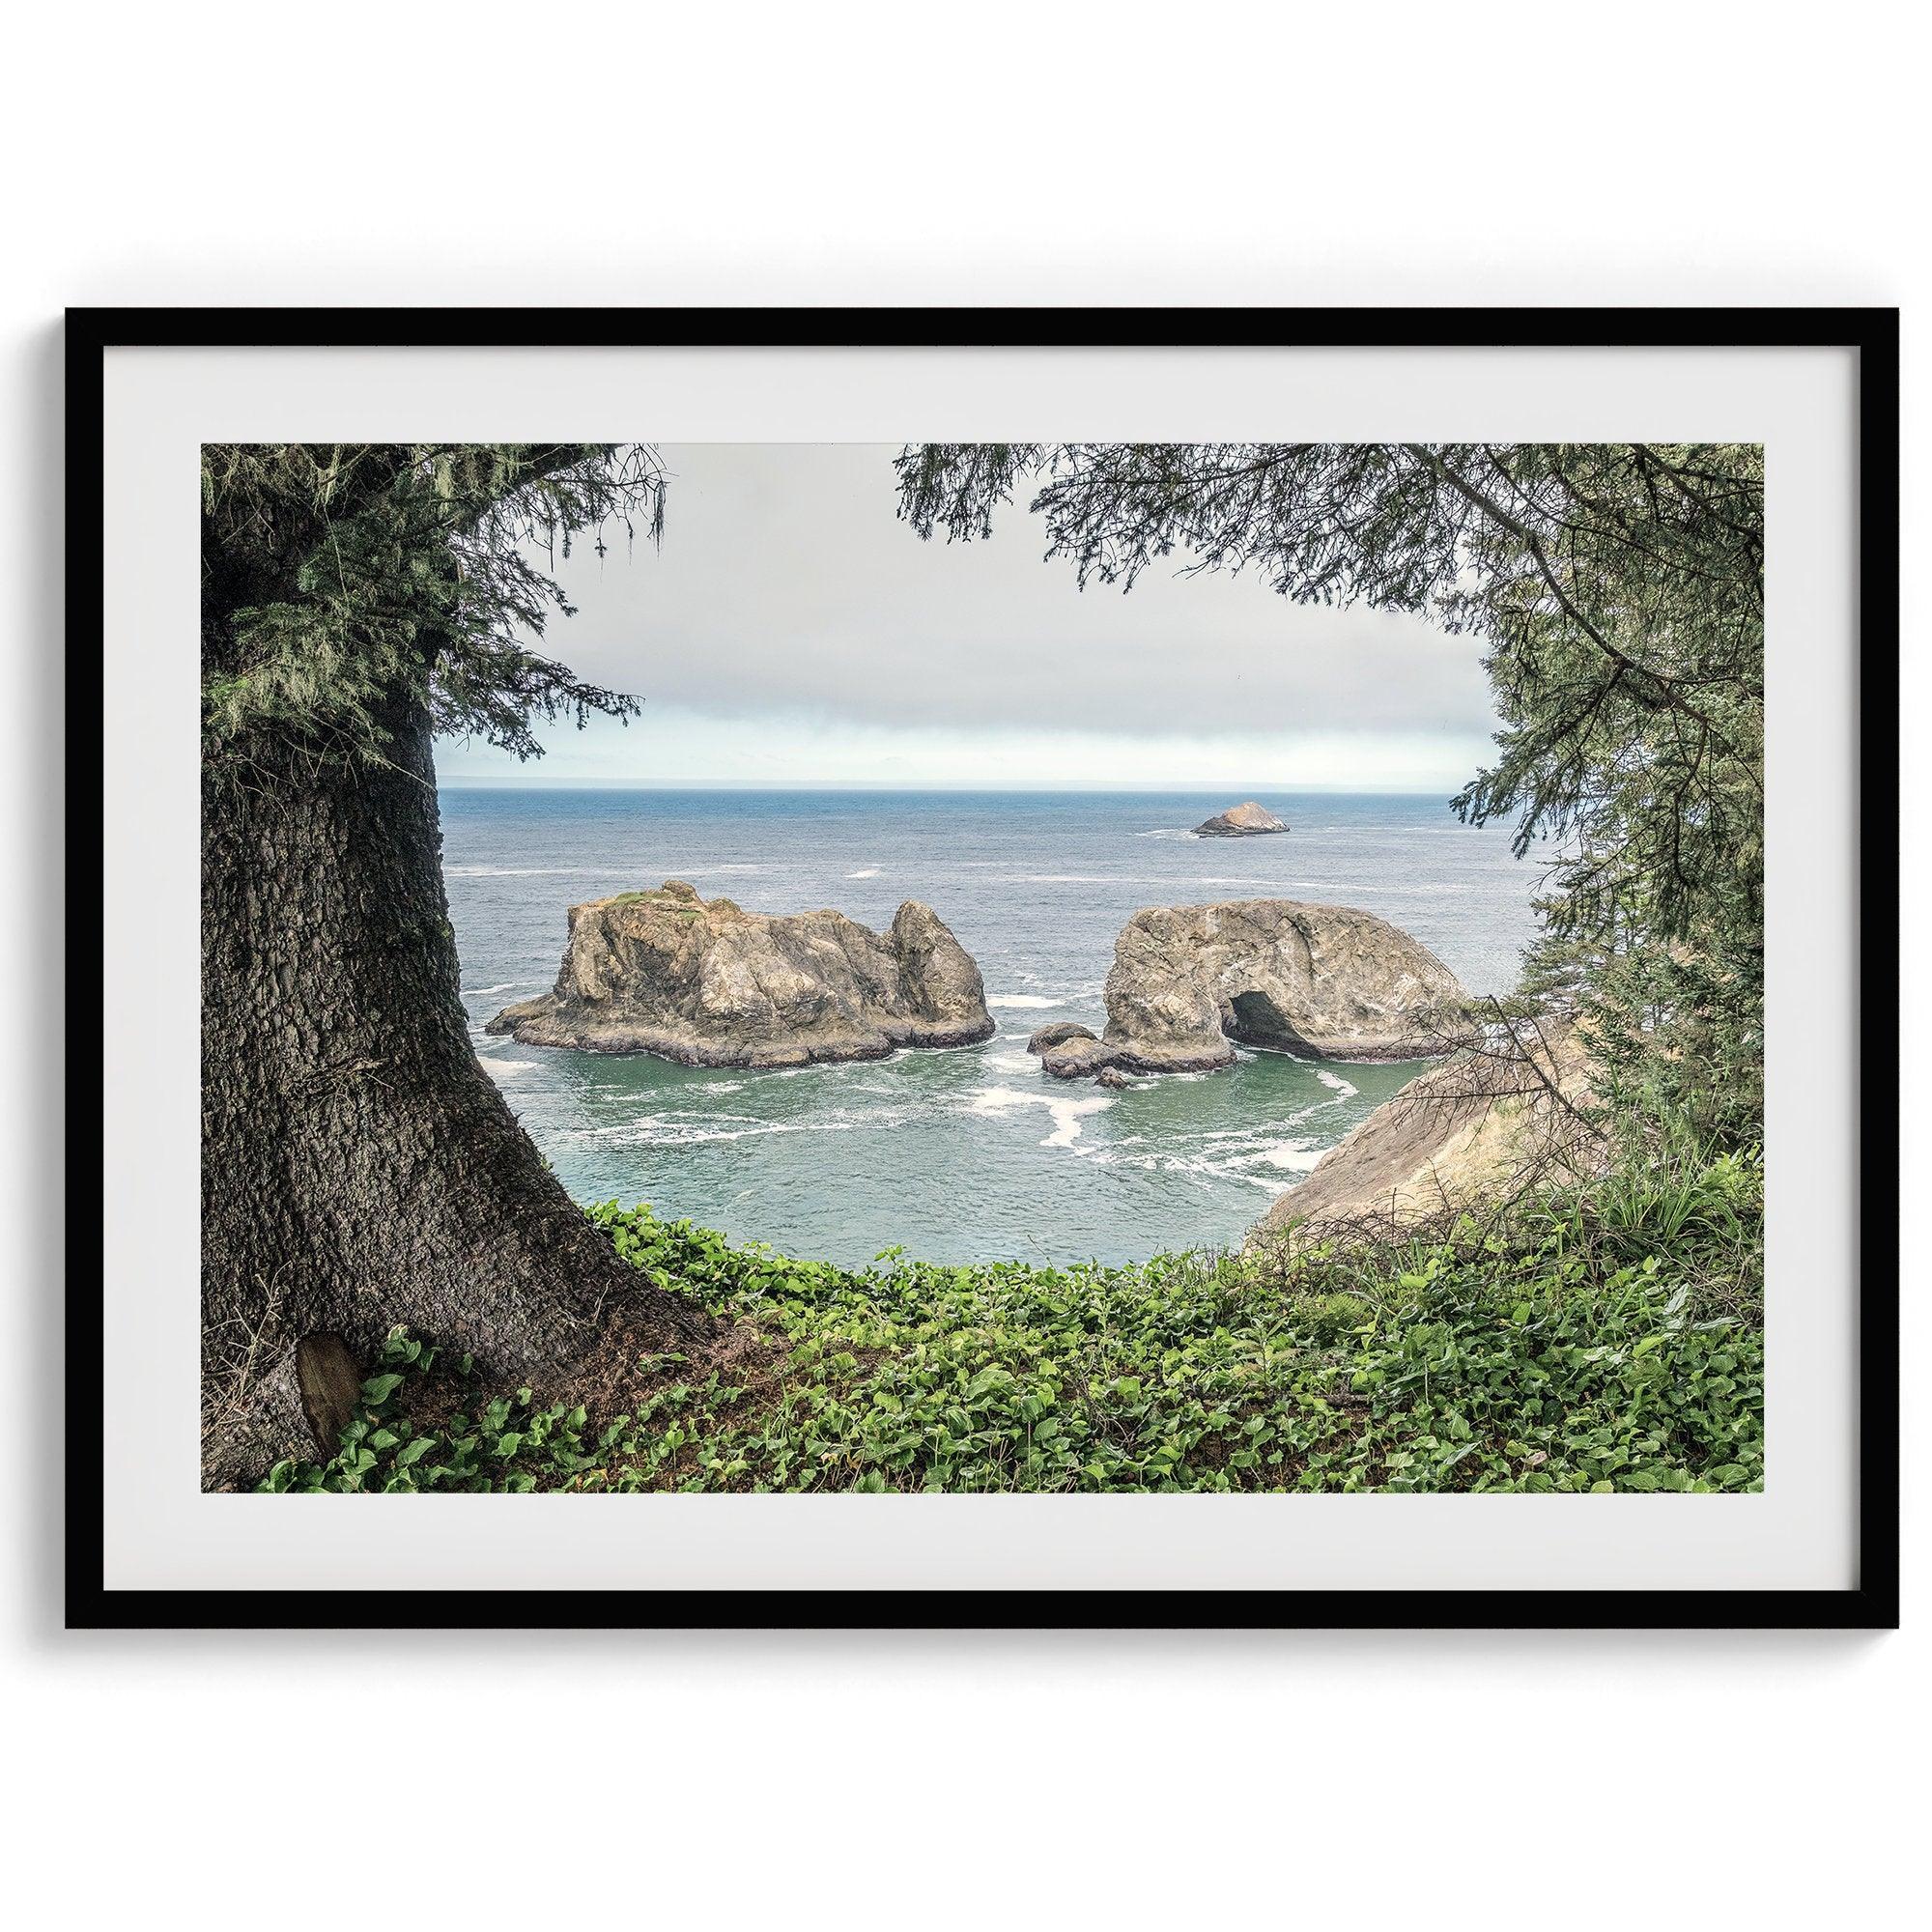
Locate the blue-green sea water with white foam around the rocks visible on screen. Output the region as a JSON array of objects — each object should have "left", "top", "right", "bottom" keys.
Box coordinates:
[{"left": 442, "top": 788, "right": 1538, "bottom": 1262}]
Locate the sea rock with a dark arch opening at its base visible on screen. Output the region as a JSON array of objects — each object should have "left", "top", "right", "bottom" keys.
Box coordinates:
[{"left": 1028, "top": 898, "right": 1468, "bottom": 1080}]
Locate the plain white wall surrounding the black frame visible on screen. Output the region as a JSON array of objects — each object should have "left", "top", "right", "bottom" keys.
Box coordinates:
[{"left": 0, "top": 0, "right": 1932, "bottom": 1926}]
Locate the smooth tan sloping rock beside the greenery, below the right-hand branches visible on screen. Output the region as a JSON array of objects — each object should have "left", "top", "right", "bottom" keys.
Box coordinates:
[{"left": 1250, "top": 1026, "right": 1607, "bottom": 1246}]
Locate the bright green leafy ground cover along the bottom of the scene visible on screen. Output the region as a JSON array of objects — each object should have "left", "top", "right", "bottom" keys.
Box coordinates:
[{"left": 263, "top": 1155, "right": 1764, "bottom": 1493}]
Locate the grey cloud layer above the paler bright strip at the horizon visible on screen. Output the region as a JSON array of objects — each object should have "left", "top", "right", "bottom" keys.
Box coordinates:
[{"left": 510, "top": 444, "right": 1493, "bottom": 736}]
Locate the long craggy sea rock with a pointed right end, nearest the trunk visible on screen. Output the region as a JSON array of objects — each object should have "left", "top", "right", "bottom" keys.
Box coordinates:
[{"left": 489, "top": 879, "right": 993, "bottom": 1066}]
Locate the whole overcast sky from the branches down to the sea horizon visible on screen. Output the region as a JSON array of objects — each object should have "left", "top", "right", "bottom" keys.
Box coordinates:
[{"left": 437, "top": 442, "right": 1495, "bottom": 794}]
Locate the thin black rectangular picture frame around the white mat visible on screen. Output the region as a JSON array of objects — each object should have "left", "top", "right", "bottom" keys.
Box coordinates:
[{"left": 66, "top": 307, "right": 1899, "bottom": 1629}]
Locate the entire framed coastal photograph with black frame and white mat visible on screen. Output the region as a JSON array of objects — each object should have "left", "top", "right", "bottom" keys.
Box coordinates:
[{"left": 68, "top": 309, "right": 1899, "bottom": 1627}]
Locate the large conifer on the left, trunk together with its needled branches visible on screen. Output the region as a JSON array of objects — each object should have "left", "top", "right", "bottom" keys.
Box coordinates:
[{"left": 201, "top": 444, "right": 701, "bottom": 1484}]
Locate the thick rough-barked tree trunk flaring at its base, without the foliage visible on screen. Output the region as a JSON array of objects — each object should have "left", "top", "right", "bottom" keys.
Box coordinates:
[{"left": 201, "top": 703, "right": 707, "bottom": 1484}]
